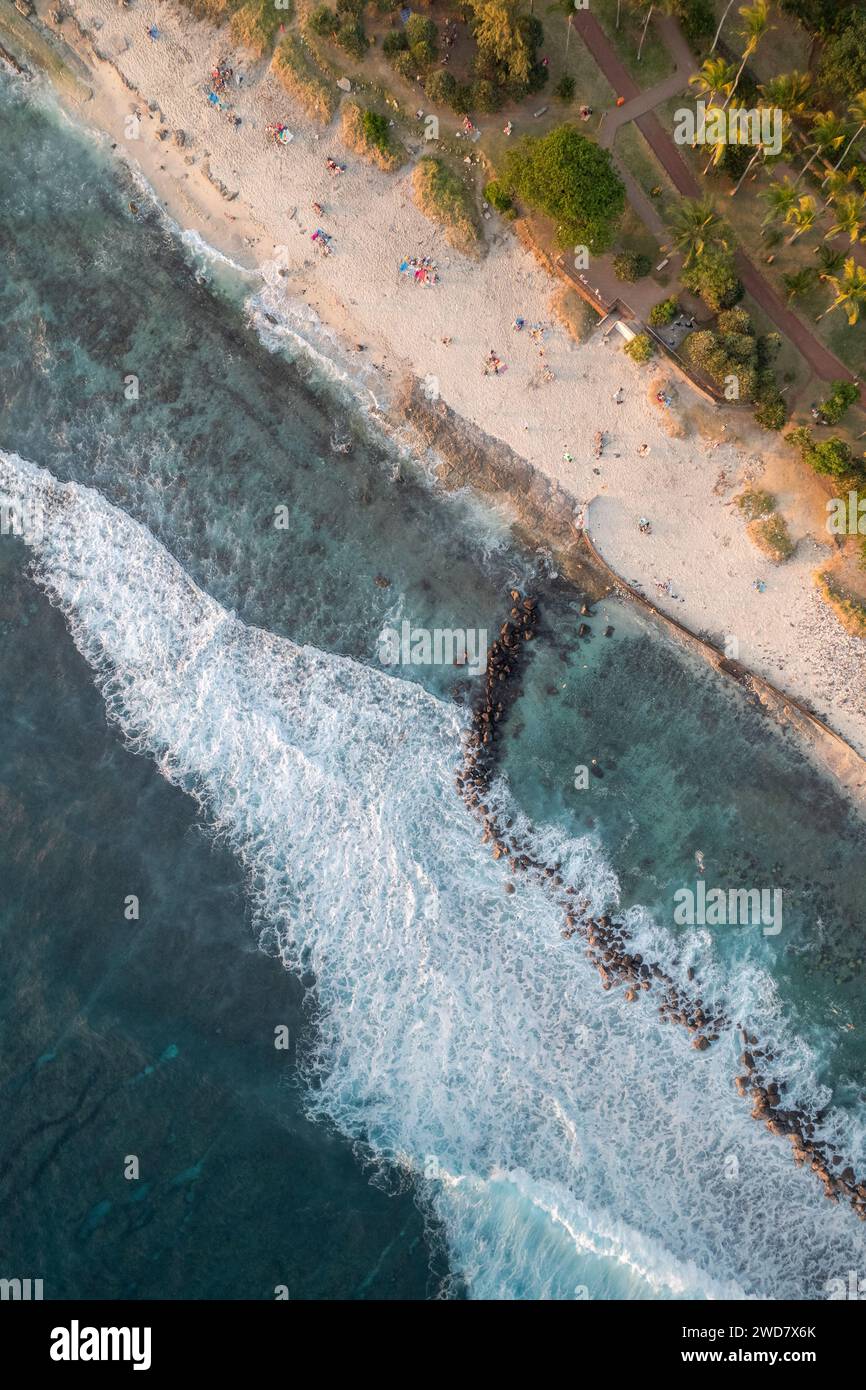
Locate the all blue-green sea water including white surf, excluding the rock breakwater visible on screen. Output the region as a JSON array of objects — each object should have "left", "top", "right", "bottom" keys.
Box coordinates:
[{"left": 0, "top": 67, "right": 866, "bottom": 1298}]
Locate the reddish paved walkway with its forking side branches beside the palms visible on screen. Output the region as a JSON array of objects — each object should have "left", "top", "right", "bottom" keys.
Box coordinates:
[{"left": 574, "top": 10, "right": 852, "bottom": 381}]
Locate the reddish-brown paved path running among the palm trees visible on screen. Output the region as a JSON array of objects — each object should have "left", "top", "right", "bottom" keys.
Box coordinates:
[{"left": 574, "top": 10, "right": 852, "bottom": 381}]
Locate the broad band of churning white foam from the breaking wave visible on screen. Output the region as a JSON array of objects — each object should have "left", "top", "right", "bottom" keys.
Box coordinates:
[{"left": 0, "top": 453, "right": 866, "bottom": 1298}]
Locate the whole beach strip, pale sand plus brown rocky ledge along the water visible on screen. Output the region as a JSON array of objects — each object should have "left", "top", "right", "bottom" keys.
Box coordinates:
[{"left": 0, "top": 0, "right": 866, "bottom": 802}]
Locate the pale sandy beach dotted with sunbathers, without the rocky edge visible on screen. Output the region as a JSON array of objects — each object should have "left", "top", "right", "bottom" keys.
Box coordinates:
[{"left": 28, "top": 0, "right": 866, "bottom": 753}]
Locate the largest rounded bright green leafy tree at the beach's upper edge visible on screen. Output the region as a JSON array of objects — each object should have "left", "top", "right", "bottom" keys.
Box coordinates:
[{"left": 506, "top": 125, "right": 626, "bottom": 252}]
